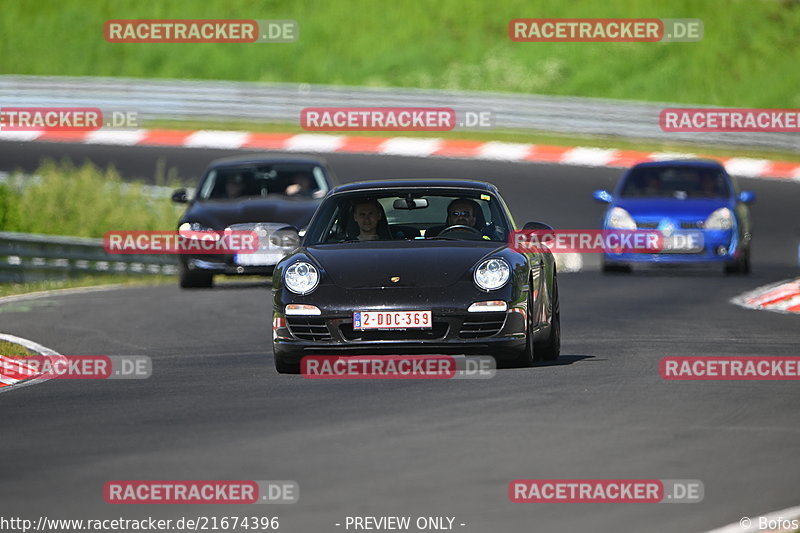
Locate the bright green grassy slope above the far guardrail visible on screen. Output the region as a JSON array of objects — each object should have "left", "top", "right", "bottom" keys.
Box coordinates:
[{"left": 0, "top": 0, "right": 800, "bottom": 108}]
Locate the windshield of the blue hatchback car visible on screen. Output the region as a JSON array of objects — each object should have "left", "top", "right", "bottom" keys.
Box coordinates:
[{"left": 620, "top": 166, "right": 729, "bottom": 199}]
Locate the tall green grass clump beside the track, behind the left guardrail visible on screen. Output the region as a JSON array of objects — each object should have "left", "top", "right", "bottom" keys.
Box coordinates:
[{"left": 0, "top": 161, "right": 181, "bottom": 237}]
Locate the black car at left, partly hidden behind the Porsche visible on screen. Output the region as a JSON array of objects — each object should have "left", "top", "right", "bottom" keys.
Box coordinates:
[{"left": 172, "top": 155, "right": 336, "bottom": 288}]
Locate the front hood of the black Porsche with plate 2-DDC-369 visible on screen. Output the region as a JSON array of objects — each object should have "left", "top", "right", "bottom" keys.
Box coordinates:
[{"left": 306, "top": 240, "right": 505, "bottom": 289}]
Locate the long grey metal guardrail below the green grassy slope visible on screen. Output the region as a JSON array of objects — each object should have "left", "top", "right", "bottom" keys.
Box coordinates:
[{"left": 0, "top": 76, "right": 800, "bottom": 151}]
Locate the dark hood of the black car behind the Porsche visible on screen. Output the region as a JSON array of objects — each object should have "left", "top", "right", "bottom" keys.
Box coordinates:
[{"left": 182, "top": 198, "right": 319, "bottom": 229}]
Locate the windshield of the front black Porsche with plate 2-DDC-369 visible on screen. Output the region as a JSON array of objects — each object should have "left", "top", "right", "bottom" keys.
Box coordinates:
[{"left": 305, "top": 192, "right": 508, "bottom": 245}]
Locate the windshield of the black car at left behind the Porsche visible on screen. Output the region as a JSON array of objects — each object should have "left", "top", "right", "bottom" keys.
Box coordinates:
[{"left": 198, "top": 163, "right": 328, "bottom": 200}]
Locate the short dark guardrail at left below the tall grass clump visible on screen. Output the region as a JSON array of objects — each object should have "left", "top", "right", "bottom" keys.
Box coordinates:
[{"left": 0, "top": 231, "right": 177, "bottom": 283}]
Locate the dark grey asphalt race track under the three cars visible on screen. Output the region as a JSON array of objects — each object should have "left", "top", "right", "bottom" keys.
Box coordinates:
[{"left": 0, "top": 142, "right": 800, "bottom": 533}]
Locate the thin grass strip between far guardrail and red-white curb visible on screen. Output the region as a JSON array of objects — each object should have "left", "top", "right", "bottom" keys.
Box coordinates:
[{"left": 150, "top": 120, "right": 800, "bottom": 162}]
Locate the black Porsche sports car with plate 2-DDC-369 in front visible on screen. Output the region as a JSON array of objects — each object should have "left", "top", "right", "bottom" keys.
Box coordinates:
[{"left": 272, "top": 180, "right": 561, "bottom": 373}]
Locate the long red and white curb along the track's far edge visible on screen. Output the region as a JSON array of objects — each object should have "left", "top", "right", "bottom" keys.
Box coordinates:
[{"left": 0, "top": 129, "right": 800, "bottom": 181}]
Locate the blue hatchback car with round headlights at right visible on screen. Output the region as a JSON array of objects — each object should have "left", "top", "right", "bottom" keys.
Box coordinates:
[{"left": 594, "top": 160, "right": 755, "bottom": 274}]
